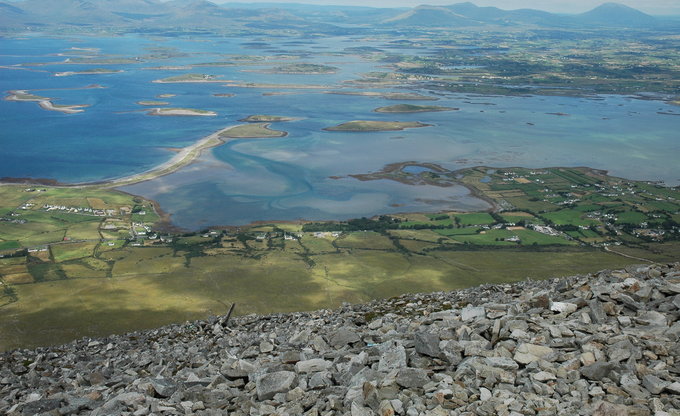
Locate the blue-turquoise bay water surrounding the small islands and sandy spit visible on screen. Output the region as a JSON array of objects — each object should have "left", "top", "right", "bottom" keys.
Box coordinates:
[{"left": 0, "top": 36, "right": 680, "bottom": 228}]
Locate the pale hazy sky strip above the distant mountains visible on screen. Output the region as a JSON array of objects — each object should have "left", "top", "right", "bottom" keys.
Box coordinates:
[{"left": 222, "top": 0, "right": 680, "bottom": 15}]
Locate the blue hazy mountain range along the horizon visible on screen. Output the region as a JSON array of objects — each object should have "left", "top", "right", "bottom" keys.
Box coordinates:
[{"left": 0, "top": 0, "right": 678, "bottom": 34}]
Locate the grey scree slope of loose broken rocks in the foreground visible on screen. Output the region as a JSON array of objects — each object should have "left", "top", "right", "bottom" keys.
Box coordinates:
[{"left": 0, "top": 264, "right": 680, "bottom": 416}]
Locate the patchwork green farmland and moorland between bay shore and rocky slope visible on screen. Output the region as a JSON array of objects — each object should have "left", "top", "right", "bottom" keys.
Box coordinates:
[{"left": 0, "top": 166, "right": 680, "bottom": 350}]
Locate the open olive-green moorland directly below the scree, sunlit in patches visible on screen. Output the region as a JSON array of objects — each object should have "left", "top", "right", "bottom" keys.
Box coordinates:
[{"left": 0, "top": 237, "right": 652, "bottom": 350}]
